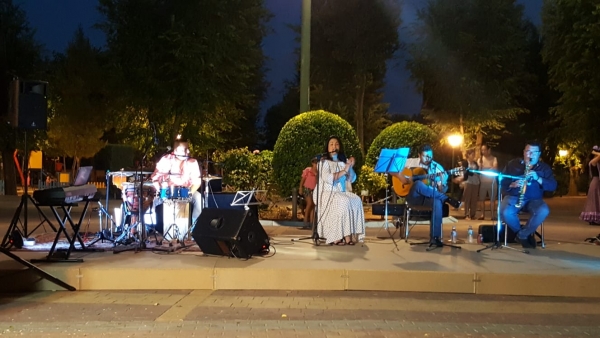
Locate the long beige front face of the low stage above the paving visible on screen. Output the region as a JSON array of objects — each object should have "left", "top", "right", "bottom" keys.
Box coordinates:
[{"left": 0, "top": 266, "right": 600, "bottom": 298}]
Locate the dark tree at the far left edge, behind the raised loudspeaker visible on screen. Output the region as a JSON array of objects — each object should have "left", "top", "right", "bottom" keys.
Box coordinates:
[{"left": 0, "top": 0, "right": 43, "bottom": 195}]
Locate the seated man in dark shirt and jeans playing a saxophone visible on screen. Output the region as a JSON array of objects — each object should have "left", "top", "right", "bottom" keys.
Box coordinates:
[{"left": 500, "top": 141, "right": 557, "bottom": 248}]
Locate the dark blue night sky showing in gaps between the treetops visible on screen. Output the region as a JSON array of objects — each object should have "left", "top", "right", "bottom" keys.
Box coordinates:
[{"left": 15, "top": 0, "right": 543, "bottom": 115}]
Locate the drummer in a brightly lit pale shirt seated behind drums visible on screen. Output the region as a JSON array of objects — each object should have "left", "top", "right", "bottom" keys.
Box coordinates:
[{"left": 150, "top": 140, "right": 202, "bottom": 224}]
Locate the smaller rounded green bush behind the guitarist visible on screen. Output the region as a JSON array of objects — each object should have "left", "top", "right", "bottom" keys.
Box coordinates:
[{"left": 365, "top": 121, "right": 439, "bottom": 167}]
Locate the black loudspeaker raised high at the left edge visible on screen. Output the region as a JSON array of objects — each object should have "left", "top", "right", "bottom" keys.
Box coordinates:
[{"left": 9, "top": 80, "right": 48, "bottom": 129}]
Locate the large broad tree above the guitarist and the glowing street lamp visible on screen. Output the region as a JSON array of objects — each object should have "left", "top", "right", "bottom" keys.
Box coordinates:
[{"left": 408, "top": 0, "right": 535, "bottom": 154}]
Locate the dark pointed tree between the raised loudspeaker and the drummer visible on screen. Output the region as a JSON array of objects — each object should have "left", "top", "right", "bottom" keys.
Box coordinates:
[{"left": 46, "top": 27, "right": 112, "bottom": 173}]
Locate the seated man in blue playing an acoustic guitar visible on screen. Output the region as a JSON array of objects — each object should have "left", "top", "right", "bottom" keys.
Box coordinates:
[{"left": 390, "top": 144, "right": 461, "bottom": 247}]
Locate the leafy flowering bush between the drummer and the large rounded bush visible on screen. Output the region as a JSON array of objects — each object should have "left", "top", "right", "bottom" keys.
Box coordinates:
[{"left": 214, "top": 148, "right": 273, "bottom": 191}]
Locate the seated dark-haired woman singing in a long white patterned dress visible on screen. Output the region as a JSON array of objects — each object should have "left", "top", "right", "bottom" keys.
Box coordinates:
[{"left": 313, "top": 136, "right": 365, "bottom": 245}]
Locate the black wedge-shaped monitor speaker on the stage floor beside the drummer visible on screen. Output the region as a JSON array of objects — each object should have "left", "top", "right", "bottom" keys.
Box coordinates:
[{"left": 192, "top": 208, "right": 270, "bottom": 258}]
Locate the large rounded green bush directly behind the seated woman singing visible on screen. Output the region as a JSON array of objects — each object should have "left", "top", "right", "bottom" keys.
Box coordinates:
[{"left": 273, "top": 110, "right": 363, "bottom": 196}]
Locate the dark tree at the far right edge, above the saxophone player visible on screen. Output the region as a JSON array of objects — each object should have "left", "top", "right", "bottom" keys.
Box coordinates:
[{"left": 542, "top": 0, "right": 600, "bottom": 153}]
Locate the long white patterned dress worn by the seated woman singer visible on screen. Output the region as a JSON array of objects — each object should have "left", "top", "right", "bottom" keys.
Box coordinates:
[{"left": 313, "top": 160, "right": 365, "bottom": 243}]
